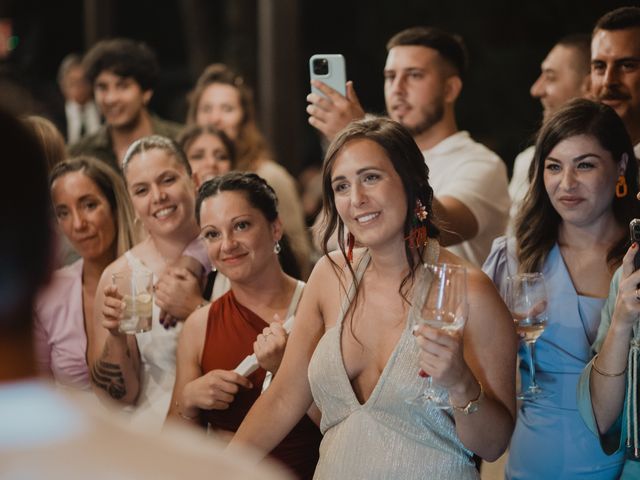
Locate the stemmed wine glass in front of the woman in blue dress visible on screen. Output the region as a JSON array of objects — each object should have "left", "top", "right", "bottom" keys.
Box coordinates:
[{"left": 506, "top": 272, "right": 548, "bottom": 400}]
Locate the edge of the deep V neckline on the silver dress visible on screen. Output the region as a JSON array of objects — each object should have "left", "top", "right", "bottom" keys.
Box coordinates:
[{"left": 332, "top": 244, "right": 440, "bottom": 408}]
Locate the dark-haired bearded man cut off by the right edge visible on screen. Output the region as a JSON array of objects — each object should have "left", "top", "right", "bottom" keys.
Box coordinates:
[{"left": 591, "top": 7, "right": 640, "bottom": 157}]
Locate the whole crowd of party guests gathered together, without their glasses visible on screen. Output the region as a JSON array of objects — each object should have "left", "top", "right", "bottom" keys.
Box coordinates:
[{"left": 0, "top": 7, "right": 640, "bottom": 480}]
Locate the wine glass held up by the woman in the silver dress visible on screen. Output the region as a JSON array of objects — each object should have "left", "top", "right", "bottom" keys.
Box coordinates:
[{"left": 407, "top": 263, "right": 469, "bottom": 409}]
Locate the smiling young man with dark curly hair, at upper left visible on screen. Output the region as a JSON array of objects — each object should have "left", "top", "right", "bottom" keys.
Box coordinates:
[{"left": 69, "top": 38, "right": 182, "bottom": 171}]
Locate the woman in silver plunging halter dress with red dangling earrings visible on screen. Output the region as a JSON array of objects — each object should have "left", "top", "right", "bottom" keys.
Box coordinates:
[{"left": 233, "top": 119, "right": 516, "bottom": 479}]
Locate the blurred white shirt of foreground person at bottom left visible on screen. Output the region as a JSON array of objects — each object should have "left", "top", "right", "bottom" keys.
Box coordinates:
[{"left": 0, "top": 381, "right": 291, "bottom": 480}]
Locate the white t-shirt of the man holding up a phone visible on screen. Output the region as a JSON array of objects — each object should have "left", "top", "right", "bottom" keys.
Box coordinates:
[{"left": 422, "top": 131, "right": 510, "bottom": 266}]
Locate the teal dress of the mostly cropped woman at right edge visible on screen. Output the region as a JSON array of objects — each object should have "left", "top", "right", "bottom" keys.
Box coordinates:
[{"left": 578, "top": 268, "right": 640, "bottom": 480}]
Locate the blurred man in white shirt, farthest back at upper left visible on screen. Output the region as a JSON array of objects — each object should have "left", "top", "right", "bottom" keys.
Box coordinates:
[{"left": 58, "top": 53, "right": 101, "bottom": 144}]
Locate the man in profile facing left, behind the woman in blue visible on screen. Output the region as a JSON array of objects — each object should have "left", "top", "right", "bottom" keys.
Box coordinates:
[{"left": 509, "top": 34, "right": 591, "bottom": 230}]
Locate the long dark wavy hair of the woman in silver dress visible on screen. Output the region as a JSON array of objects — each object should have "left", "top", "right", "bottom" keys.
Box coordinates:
[{"left": 322, "top": 118, "right": 440, "bottom": 299}]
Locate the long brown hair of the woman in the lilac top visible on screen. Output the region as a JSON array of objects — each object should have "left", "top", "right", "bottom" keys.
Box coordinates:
[{"left": 49, "top": 156, "right": 138, "bottom": 257}]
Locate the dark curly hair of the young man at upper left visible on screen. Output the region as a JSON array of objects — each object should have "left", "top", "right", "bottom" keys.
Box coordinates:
[{"left": 82, "top": 38, "right": 160, "bottom": 91}]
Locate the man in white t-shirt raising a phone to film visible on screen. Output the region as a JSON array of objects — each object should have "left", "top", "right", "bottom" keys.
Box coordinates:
[{"left": 307, "top": 27, "right": 510, "bottom": 265}]
